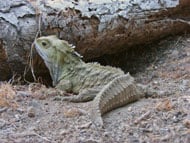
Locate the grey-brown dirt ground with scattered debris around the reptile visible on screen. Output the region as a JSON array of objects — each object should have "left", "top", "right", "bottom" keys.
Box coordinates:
[{"left": 0, "top": 36, "right": 190, "bottom": 143}]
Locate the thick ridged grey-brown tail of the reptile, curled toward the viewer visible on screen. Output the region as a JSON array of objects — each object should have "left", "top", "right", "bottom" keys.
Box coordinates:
[{"left": 90, "top": 74, "right": 142, "bottom": 127}]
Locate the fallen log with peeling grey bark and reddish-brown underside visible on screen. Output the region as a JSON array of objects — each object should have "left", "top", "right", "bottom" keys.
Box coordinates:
[{"left": 0, "top": 0, "right": 190, "bottom": 80}]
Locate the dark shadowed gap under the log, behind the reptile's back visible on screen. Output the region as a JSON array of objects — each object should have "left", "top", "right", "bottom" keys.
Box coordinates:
[{"left": 88, "top": 37, "right": 181, "bottom": 75}]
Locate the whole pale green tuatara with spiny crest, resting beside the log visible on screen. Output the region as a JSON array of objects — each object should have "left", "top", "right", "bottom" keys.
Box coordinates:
[{"left": 34, "top": 36, "right": 144, "bottom": 126}]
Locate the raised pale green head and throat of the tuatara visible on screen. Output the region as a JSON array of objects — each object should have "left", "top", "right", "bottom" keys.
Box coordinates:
[{"left": 34, "top": 35, "right": 81, "bottom": 83}]
